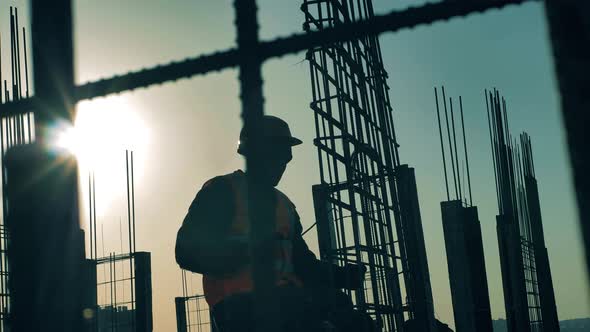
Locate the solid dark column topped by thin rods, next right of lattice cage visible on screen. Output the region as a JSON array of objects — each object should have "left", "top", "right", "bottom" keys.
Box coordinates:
[{"left": 434, "top": 87, "right": 493, "bottom": 332}]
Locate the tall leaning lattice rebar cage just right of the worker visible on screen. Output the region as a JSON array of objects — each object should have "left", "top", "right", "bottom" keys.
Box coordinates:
[{"left": 301, "top": 0, "right": 407, "bottom": 331}]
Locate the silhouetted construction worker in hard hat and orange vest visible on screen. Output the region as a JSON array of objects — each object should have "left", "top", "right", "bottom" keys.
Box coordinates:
[{"left": 176, "top": 115, "right": 373, "bottom": 332}]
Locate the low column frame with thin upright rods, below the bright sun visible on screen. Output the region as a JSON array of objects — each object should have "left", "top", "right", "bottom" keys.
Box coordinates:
[{"left": 84, "top": 150, "right": 153, "bottom": 332}]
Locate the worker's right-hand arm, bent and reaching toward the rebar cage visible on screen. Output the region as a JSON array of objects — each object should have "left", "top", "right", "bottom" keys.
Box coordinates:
[{"left": 293, "top": 209, "right": 365, "bottom": 289}]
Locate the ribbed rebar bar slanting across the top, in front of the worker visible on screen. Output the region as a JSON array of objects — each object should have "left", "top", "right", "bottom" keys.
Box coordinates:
[{"left": 0, "top": 0, "right": 540, "bottom": 117}]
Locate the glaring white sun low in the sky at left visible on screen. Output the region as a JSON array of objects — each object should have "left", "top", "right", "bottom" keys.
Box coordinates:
[{"left": 56, "top": 96, "right": 149, "bottom": 216}]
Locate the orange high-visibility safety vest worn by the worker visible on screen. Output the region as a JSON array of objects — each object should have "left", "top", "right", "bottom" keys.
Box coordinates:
[{"left": 203, "top": 171, "right": 302, "bottom": 306}]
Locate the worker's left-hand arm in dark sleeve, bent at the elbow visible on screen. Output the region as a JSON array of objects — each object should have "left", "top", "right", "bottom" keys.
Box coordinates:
[{"left": 175, "top": 177, "right": 248, "bottom": 275}]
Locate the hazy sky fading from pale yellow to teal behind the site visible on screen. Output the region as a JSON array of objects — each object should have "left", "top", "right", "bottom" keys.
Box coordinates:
[{"left": 0, "top": 0, "right": 590, "bottom": 331}]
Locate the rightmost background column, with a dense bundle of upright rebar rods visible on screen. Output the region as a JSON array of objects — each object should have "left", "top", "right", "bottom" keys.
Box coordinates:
[{"left": 485, "top": 89, "right": 559, "bottom": 332}]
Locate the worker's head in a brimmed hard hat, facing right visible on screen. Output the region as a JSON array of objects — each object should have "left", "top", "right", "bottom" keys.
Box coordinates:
[{"left": 238, "top": 115, "right": 301, "bottom": 186}]
